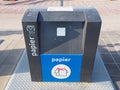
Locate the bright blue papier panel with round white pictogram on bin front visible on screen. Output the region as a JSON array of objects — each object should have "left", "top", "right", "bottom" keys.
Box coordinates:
[{"left": 40, "top": 54, "right": 82, "bottom": 82}]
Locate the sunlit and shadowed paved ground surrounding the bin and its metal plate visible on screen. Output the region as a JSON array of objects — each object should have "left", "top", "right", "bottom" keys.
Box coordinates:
[{"left": 0, "top": 0, "right": 120, "bottom": 90}]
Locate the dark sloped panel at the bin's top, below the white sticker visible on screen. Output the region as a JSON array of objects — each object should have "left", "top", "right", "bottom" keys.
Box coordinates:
[{"left": 38, "top": 11, "right": 85, "bottom": 22}]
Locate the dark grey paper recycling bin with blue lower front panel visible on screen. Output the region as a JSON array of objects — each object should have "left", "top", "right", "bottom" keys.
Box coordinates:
[{"left": 22, "top": 7, "right": 101, "bottom": 82}]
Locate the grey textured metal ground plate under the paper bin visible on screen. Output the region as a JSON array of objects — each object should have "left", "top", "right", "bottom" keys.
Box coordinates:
[{"left": 5, "top": 51, "right": 116, "bottom": 90}]
